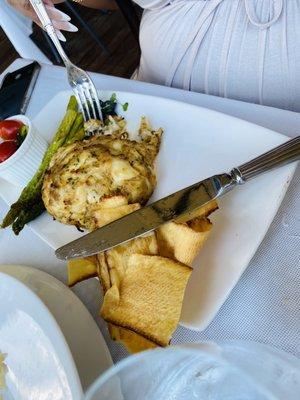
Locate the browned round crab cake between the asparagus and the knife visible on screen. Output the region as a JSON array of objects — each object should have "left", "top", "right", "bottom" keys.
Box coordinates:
[{"left": 42, "top": 129, "right": 162, "bottom": 230}]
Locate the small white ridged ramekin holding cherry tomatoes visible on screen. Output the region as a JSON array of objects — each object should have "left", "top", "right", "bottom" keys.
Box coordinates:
[{"left": 0, "top": 115, "right": 48, "bottom": 186}]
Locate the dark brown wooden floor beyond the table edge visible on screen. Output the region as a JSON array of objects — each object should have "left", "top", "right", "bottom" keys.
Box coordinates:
[{"left": 0, "top": 3, "right": 140, "bottom": 78}]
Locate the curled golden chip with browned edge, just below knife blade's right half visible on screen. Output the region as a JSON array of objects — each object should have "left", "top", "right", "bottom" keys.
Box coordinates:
[{"left": 156, "top": 218, "right": 212, "bottom": 266}]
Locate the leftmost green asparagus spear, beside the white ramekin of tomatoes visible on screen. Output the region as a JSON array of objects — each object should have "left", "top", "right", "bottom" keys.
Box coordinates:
[{"left": 1, "top": 96, "right": 78, "bottom": 228}]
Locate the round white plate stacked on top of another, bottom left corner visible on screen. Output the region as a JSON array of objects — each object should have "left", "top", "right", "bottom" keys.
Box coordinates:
[{"left": 0, "top": 273, "right": 82, "bottom": 400}]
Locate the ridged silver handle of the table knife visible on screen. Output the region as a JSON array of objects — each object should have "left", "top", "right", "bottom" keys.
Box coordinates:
[{"left": 231, "top": 136, "right": 300, "bottom": 184}]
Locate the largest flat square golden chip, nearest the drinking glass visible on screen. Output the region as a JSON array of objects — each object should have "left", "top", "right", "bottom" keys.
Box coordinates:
[{"left": 101, "top": 254, "right": 192, "bottom": 346}]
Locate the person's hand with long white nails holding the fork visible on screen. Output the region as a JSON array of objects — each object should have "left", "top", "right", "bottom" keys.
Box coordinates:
[{"left": 7, "top": 0, "right": 78, "bottom": 41}]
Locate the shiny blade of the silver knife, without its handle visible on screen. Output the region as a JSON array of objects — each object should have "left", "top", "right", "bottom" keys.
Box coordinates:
[{"left": 55, "top": 174, "right": 237, "bottom": 260}]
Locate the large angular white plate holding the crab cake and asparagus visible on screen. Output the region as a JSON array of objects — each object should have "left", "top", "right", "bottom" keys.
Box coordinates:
[{"left": 1, "top": 92, "right": 296, "bottom": 330}]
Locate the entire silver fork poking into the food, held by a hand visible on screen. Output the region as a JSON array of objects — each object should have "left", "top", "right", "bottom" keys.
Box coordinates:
[{"left": 30, "top": 0, "right": 103, "bottom": 121}]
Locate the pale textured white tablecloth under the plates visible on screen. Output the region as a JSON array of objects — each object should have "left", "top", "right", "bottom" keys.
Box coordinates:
[{"left": 0, "top": 60, "right": 300, "bottom": 361}]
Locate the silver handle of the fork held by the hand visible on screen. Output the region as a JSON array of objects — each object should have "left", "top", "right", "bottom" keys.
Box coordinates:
[{"left": 29, "top": 0, "right": 71, "bottom": 66}]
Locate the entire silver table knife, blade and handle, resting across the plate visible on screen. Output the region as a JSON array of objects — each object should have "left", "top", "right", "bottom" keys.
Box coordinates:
[{"left": 55, "top": 136, "right": 300, "bottom": 260}]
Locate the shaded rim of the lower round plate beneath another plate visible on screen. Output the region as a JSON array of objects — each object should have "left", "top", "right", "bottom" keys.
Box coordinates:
[{"left": 0, "top": 265, "right": 113, "bottom": 390}]
